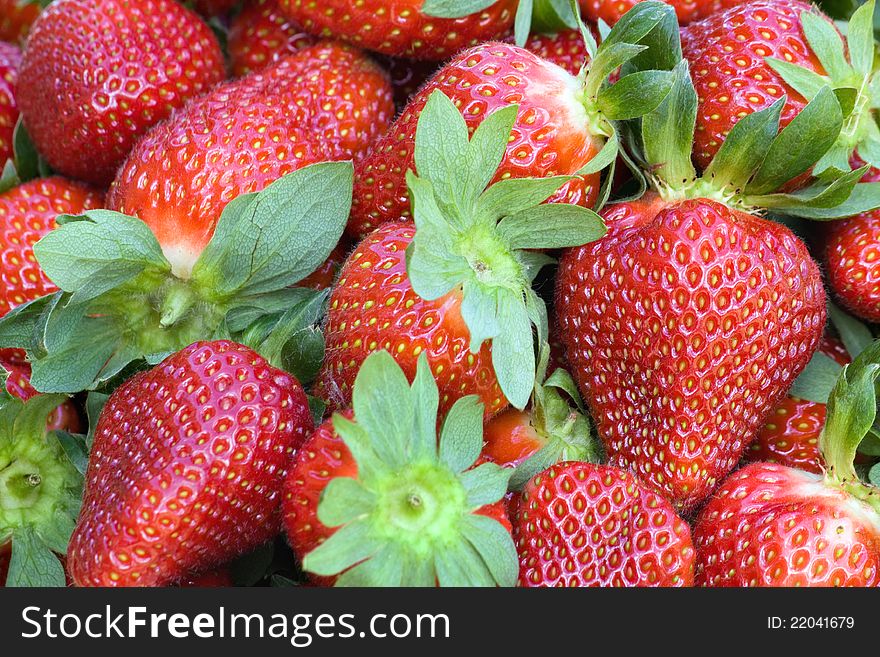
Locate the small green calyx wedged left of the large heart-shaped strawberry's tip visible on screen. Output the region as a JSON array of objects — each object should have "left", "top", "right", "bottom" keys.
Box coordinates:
[{"left": 510, "top": 343, "right": 603, "bottom": 490}]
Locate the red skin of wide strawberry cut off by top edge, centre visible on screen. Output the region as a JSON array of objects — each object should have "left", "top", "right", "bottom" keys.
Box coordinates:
[{"left": 280, "top": 0, "right": 517, "bottom": 61}]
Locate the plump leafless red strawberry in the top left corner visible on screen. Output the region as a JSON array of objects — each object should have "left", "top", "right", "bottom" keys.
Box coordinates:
[{"left": 17, "top": 0, "right": 225, "bottom": 185}]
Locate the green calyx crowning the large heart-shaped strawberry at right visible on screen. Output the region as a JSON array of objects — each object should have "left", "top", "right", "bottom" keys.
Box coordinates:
[{"left": 627, "top": 49, "right": 880, "bottom": 220}]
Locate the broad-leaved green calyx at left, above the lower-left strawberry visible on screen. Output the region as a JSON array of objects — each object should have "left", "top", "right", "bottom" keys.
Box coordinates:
[{"left": 0, "top": 162, "right": 353, "bottom": 393}]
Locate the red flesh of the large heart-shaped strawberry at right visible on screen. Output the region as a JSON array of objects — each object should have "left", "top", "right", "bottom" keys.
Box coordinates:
[{"left": 556, "top": 192, "right": 825, "bottom": 511}]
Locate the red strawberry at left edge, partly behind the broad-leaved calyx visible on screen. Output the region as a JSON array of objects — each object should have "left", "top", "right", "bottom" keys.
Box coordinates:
[{"left": 0, "top": 176, "right": 104, "bottom": 316}]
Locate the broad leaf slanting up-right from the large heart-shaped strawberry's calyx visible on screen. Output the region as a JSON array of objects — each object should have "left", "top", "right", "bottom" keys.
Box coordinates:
[{"left": 746, "top": 87, "right": 843, "bottom": 195}]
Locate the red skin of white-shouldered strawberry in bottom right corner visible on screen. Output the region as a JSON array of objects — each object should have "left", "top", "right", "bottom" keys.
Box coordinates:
[{"left": 694, "top": 463, "right": 880, "bottom": 586}]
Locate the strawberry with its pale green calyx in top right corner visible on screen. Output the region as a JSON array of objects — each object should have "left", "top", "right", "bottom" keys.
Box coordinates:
[{"left": 682, "top": 0, "right": 880, "bottom": 182}]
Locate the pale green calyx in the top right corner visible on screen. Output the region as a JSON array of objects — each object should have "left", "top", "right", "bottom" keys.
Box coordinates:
[{"left": 765, "top": 0, "right": 880, "bottom": 174}]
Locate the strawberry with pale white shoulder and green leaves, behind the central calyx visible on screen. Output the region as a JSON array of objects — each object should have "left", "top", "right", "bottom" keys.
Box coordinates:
[{"left": 348, "top": 2, "right": 674, "bottom": 237}]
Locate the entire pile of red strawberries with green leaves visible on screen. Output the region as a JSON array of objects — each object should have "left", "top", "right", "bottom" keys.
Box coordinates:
[{"left": 0, "top": 0, "right": 880, "bottom": 586}]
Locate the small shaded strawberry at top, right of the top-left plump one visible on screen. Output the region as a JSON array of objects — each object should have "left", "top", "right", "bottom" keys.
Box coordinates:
[{"left": 228, "top": 0, "right": 317, "bottom": 76}]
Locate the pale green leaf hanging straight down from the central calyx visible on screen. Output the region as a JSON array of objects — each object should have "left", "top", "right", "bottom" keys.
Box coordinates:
[{"left": 492, "top": 293, "right": 535, "bottom": 409}]
